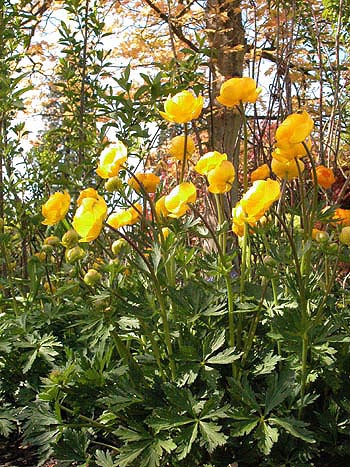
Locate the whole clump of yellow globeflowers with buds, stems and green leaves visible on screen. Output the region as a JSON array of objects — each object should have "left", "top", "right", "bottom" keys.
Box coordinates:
[{"left": 0, "top": 78, "right": 350, "bottom": 467}]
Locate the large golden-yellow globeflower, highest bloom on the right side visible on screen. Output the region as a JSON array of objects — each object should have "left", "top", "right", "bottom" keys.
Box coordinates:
[{"left": 275, "top": 110, "right": 314, "bottom": 149}]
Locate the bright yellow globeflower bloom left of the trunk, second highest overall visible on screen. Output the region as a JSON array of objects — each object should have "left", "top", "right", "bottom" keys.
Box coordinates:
[{"left": 159, "top": 91, "right": 203, "bottom": 123}]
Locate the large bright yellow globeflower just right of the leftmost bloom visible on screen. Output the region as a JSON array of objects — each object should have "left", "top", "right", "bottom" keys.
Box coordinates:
[{"left": 72, "top": 195, "right": 107, "bottom": 242}]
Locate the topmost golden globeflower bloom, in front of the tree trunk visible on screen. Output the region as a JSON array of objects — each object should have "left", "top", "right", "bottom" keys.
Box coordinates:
[{"left": 217, "top": 77, "right": 261, "bottom": 107}]
